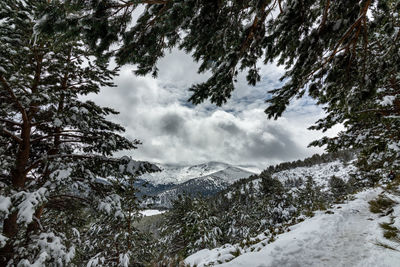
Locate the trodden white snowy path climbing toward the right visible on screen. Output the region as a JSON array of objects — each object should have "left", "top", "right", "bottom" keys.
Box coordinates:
[{"left": 222, "top": 190, "right": 400, "bottom": 267}]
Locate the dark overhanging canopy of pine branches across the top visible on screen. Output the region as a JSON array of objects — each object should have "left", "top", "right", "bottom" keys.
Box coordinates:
[{"left": 39, "top": 0, "right": 400, "bottom": 172}]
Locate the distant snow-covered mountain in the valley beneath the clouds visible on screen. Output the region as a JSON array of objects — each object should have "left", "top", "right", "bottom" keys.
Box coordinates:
[{"left": 137, "top": 161, "right": 254, "bottom": 208}]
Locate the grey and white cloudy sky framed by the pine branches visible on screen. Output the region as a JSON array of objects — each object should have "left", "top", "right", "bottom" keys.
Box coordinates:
[{"left": 91, "top": 50, "right": 338, "bottom": 169}]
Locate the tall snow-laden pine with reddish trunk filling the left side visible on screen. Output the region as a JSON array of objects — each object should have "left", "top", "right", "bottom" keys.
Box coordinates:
[{"left": 0, "top": 0, "right": 155, "bottom": 266}]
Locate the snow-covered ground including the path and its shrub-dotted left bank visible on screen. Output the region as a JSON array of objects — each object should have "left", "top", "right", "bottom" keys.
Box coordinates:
[{"left": 185, "top": 188, "right": 400, "bottom": 267}]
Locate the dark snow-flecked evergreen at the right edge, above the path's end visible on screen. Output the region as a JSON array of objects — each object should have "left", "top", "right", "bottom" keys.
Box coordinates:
[{"left": 312, "top": 1, "right": 400, "bottom": 177}]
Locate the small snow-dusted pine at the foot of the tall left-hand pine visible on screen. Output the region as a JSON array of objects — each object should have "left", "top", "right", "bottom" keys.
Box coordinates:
[{"left": 82, "top": 178, "right": 154, "bottom": 266}]
